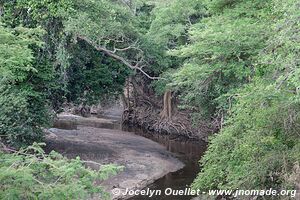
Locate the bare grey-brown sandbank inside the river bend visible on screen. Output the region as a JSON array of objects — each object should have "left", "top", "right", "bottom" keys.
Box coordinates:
[{"left": 46, "top": 115, "right": 184, "bottom": 199}]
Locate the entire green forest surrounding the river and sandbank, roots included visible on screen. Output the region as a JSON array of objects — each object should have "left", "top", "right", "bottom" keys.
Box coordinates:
[{"left": 0, "top": 0, "right": 300, "bottom": 199}]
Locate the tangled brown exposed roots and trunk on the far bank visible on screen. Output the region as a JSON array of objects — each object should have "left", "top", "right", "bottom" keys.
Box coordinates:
[{"left": 123, "top": 77, "right": 217, "bottom": 140}]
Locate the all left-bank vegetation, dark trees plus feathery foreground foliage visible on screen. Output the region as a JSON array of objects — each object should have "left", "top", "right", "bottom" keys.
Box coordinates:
[{"left": 0, "top": 0, "right": 128, "bottom": 199}]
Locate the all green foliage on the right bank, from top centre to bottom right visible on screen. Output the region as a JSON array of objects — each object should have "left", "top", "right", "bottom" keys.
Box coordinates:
[{"left": 144, "top": 0, "right": 300, "bottom": 197}]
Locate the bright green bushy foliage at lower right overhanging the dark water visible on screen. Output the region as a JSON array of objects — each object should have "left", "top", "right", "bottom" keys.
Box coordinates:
[{"left": 194, "top": 82, "right": 300, "bottom": 190}]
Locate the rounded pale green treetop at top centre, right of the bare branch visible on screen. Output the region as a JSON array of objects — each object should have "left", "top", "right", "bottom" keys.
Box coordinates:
[{"left": 147, "top": 0, "right": 206, "bottom": 50}]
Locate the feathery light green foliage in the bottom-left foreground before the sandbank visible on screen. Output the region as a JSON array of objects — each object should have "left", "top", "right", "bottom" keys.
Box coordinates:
[{"left": 0, "top": 143, "right": 122, "bottom": 199}]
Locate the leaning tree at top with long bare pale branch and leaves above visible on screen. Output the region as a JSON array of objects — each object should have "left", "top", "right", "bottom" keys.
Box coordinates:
[{"left": 65, "top": 0, "right": 157, "bottom": 79}]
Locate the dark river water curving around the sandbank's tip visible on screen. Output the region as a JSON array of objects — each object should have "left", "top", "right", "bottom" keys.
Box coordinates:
[{"left": 54, "top": 116, "right": 206, "bottom": 200}]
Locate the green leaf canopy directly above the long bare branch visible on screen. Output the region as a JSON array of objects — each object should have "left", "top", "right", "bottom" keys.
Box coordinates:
[{"left": 64, "top": 0, "right": 136, "bottom": 45}]
